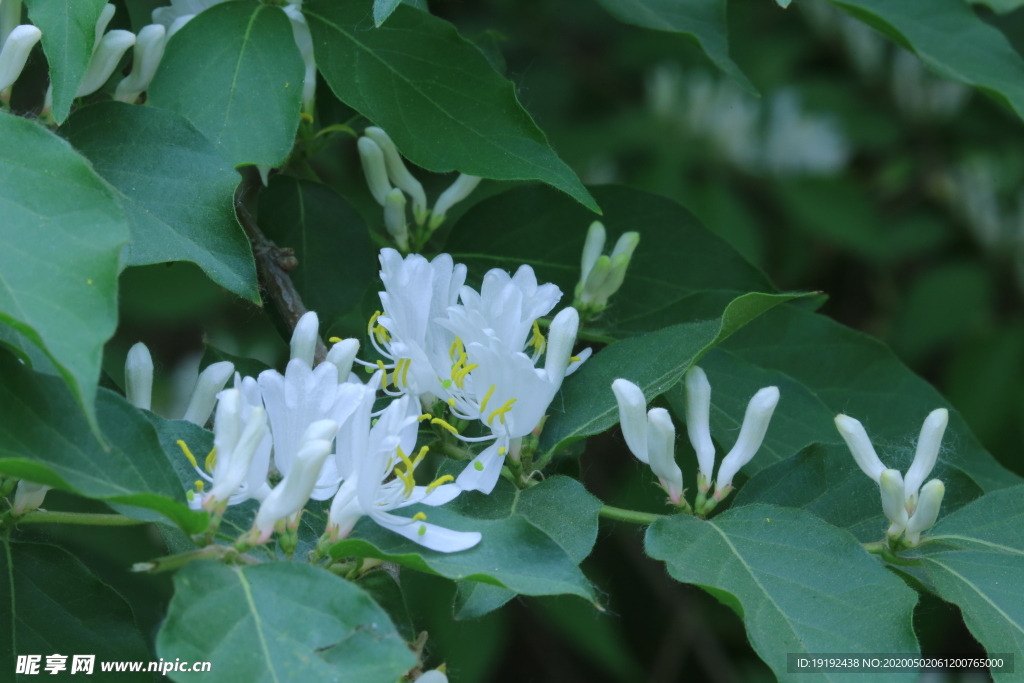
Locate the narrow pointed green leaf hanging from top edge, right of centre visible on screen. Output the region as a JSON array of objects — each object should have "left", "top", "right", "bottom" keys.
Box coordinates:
[{"left": 597, "top": 0, "right": 757, "bottom": 95}]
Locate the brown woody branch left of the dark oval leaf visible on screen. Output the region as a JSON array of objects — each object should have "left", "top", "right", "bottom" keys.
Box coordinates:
[{"left": 234, "top": 168, "right": 327, "bottom": 364}]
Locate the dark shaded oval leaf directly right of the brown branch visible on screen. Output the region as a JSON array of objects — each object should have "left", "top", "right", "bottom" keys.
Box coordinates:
[{"left": 259, "top": 175, "right": 377, "bottom": 330}]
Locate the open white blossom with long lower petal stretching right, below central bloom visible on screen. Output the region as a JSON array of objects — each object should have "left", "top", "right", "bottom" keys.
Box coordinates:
[{"left": 326, "top": 393, "right": 481, "bottom": 553}]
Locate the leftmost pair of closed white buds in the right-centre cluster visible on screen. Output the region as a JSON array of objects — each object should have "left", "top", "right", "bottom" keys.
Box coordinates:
[{"left": 611, "top": 379, "right": 685, "bottom": 505}]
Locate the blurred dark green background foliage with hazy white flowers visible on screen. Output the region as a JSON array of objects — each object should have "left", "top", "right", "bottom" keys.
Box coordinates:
[{"left": 88, "top": 0, "right": 1024, "bottom": 682}]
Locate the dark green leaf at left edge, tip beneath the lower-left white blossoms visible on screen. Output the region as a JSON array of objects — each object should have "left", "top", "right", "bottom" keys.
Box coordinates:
[{"left": 0, "top": 353, "right": 206, "bottom": 532}]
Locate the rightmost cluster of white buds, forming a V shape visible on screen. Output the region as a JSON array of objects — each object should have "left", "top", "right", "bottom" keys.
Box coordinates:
[{"left": 836, "top": 408, "right": 949, "bottom": 546}]
